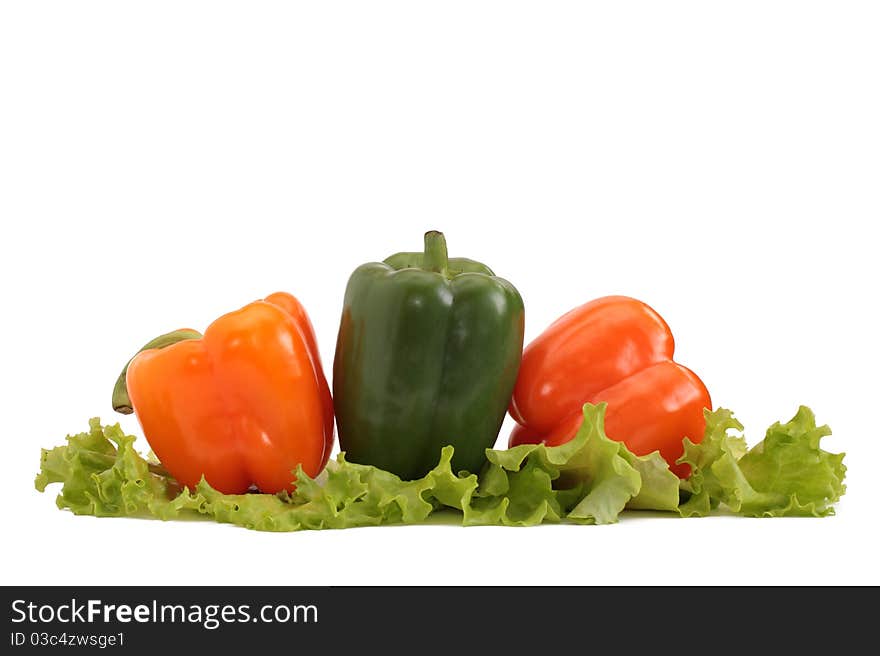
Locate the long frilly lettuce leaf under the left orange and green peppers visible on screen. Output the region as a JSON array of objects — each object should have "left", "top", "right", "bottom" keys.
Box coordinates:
[{"left": 34, "top": 419, "right": 477, "bottom": 531}]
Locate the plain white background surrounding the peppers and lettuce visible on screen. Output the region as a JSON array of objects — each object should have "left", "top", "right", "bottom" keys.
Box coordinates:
[{"left": 0, "top": 0, "right": 880, "bottom": 585}]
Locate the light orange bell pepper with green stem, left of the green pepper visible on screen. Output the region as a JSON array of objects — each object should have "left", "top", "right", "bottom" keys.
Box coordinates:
[{"left": 113, "top": 292, "right": 333, "bottom": 494}]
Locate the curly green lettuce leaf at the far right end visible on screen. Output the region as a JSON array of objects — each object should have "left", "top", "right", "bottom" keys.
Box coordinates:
[{"left": 679, "top": 406, "right": 846, "bottom": 517}]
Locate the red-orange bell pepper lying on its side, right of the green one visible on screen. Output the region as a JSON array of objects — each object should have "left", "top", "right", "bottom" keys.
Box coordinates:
[{"left": 509, "top": 296, "right": 712, "bottom": 478}]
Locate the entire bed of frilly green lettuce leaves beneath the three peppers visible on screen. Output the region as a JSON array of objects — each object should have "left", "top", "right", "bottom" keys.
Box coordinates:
[{"left": 35, "top": 404, "right": 845, "bottom": 531}]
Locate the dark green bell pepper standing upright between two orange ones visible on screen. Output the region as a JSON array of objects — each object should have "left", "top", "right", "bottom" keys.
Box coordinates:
[{"left": 333, "top": 232, "right": 524, "bottom": 479}]
